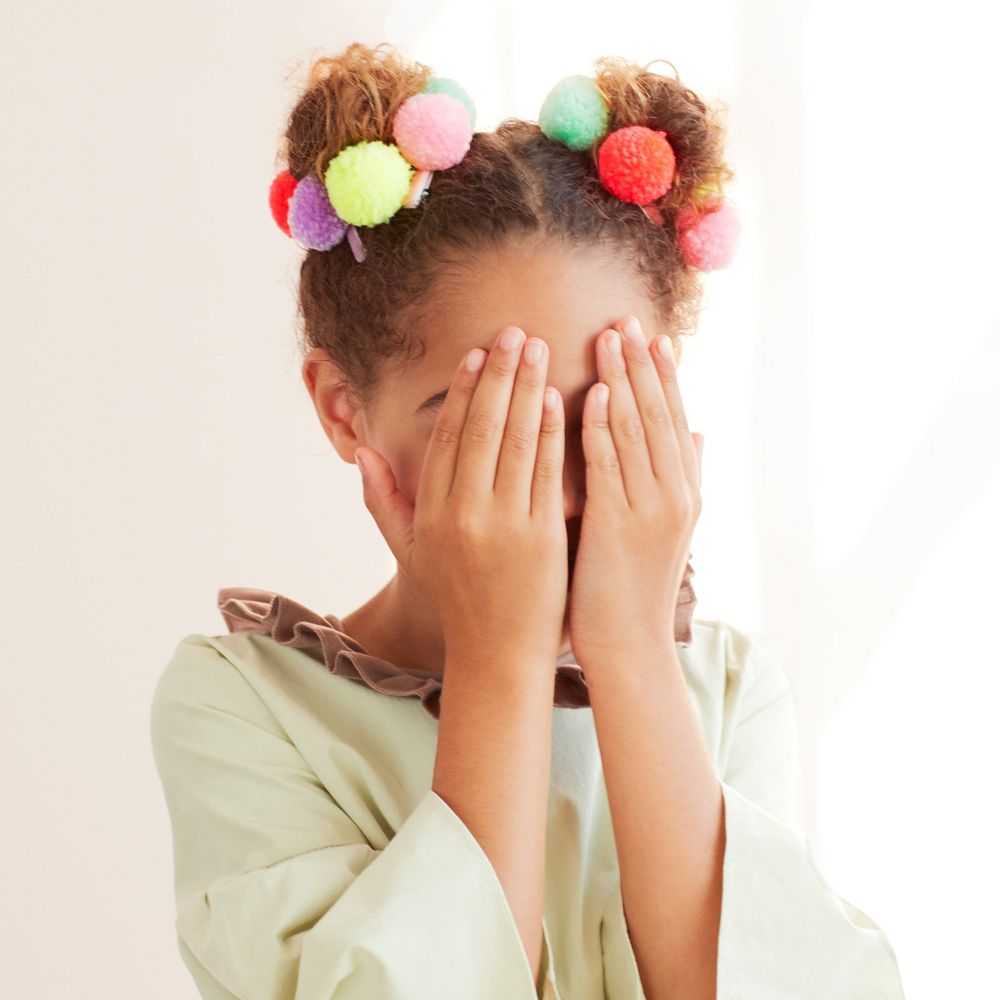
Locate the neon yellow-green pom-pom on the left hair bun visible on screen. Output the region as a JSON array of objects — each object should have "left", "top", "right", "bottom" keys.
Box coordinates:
[{"left": 324, "top": 140, "right": 414, "bottom": 226}]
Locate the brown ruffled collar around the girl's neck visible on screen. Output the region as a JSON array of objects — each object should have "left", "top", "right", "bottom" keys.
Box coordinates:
[{"left": 218, "top": 562, "right": 697, "bottom": 719}]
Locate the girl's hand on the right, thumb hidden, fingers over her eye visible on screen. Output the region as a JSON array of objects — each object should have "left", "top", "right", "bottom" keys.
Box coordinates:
[{"left": 569, "top": 316, "right": 704, "bottom": 672}]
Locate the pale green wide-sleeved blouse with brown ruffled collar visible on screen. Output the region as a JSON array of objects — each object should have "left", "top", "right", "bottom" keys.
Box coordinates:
[{"left": 151, "top": 590, "right": 903, "bottom": 1000}]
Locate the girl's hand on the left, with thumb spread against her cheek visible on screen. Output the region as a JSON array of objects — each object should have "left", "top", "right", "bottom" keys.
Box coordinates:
[{"left": 355, "top": 327, "right": 568, "bottom": 663}]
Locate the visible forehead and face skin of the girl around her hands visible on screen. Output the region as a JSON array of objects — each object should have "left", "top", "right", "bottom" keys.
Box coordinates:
[{"left": 356, "top": 239, "right": 680, "bottom": 556}]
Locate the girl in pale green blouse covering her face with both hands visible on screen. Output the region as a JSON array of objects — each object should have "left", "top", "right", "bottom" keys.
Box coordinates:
[{"left": 152, "top": 44, "right": 902, "bottom": 1000}]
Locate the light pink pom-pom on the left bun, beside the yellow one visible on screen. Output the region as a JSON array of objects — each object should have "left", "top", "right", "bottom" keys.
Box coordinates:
[{"left": 392, "top": 93, "right": 472, "bottom": 170}]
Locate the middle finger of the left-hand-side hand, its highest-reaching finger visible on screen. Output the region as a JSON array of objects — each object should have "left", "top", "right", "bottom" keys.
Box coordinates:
[{"left": 452, "top": 326, "right": 525, "bottom": 502}]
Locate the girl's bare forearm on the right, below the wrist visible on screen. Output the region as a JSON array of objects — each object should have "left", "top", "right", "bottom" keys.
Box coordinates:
[{"left": 582, "top": 638, "right": 726, "bottom": 1000}]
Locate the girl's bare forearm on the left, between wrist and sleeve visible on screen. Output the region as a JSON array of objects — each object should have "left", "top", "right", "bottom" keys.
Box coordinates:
[{"left": 432, "top": 653, "right": 555, "bottom": 983}]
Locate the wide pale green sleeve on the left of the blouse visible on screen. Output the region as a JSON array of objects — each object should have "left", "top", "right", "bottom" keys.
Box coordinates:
[{"left": 150, "top": 636, "right": 555, "bottom": 1000}]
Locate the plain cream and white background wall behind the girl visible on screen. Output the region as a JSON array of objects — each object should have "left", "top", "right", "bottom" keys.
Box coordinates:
[{"left": 0, "top": 0, "right": 1000, "bottom": 1000}]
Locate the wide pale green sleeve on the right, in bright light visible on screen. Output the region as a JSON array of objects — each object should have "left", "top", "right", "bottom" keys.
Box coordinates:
[{"left": 601, "top": 635, "right": 903, "bottom": 1000}]
